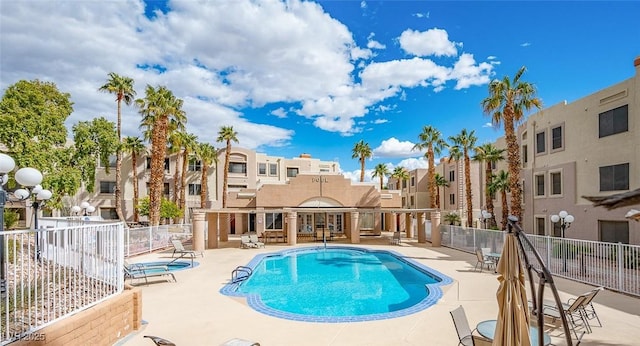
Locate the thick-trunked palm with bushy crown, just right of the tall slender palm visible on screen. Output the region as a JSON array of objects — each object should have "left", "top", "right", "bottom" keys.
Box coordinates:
[{"left": 136, "top": 85, "right": 187, "bottom": 226}]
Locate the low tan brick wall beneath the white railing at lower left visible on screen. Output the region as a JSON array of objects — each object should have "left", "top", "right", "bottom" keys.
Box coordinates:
[{"left": 12, "top": 286, "right": 142, "bottom": 346}]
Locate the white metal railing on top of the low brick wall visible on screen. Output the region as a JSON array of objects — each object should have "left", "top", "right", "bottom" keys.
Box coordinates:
[{"left": 0, "top": 223, "right": 124, "bottom": 345}]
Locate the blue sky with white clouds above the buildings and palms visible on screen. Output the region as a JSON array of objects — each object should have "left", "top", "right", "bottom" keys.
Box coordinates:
[{"left": 0, "top": 0, "right": 640, "bottom": 181}]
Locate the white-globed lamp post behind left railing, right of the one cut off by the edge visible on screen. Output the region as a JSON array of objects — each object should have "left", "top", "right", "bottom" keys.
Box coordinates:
[{"left": 13, "top": 167, "right": 52, "bottom": 260}]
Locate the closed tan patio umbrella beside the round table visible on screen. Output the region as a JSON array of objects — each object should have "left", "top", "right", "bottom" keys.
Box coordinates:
[{"left": 493, "top": 232, "right": 531, "bottom": 346}]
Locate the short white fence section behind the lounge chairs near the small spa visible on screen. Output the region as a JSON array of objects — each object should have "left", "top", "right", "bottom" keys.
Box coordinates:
[{"left": 124, "top": 224, "right": 191, "bottom": 257}]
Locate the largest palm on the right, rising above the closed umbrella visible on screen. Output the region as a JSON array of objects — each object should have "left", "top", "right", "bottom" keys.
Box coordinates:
[{"left": 482, "top": 66, "right": 542, "bottom": 220}]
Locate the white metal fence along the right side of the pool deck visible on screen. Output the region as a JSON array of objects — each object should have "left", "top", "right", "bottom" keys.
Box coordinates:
[{"left": 440, "top": 225, "right": 640, "bottom": 296}]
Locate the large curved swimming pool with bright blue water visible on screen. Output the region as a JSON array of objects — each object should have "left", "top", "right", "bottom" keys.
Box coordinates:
[{"left": 220, "top": 246, "right": 452, "bottom": 322}]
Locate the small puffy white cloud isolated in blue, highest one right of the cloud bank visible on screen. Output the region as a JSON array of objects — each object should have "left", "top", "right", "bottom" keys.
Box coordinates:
[{"left": 399, "top": 28, "right": 459, "bottom": 56}]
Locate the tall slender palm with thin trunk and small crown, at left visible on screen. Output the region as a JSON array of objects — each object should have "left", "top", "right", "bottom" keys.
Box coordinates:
[{"left": 98, "top": 72, "right": 136, "bottom": 220}]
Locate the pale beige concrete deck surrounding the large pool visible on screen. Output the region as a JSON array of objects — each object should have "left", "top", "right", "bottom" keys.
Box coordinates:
[{"left": 118, "top": 234, "right": 640, "bottom": 346}]
